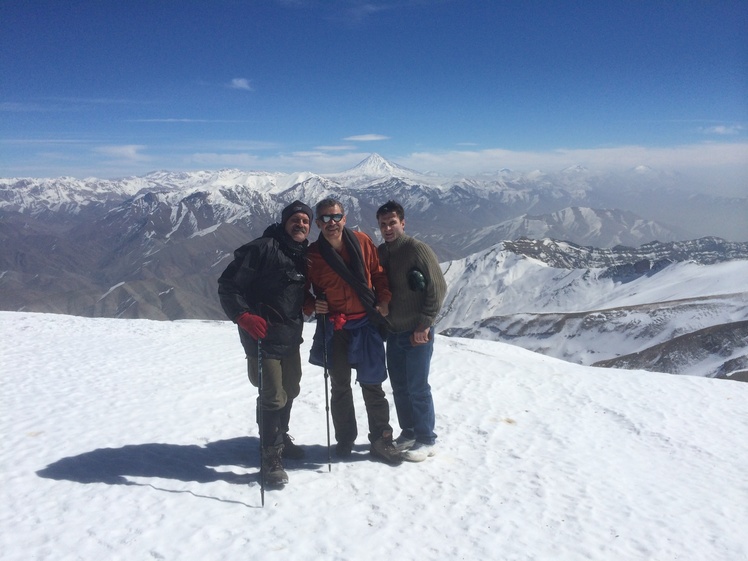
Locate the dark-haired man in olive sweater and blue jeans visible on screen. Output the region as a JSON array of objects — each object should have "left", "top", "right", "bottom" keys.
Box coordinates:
[{"left": 377, "top": 201, "right": 447, "bottom": 462}]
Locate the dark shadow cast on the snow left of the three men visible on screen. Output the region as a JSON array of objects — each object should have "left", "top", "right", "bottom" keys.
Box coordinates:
[{"left": 36, "top": 436, "right": 328, "bottom": 485}]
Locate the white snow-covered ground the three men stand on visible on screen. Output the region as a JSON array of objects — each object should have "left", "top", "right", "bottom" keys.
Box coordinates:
[{"left": 0, "top": 312, "right": 748, "bottom": 561}]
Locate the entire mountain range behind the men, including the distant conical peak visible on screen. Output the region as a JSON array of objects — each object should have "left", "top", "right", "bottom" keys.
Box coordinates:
[{"left": 0, "top": 154, "right": 748, "bottom": 376}]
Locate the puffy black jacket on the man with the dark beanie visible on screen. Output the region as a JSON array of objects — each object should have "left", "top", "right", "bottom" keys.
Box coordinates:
[{"left": 218, "top": 224, "right": 307, "bottom": 358}]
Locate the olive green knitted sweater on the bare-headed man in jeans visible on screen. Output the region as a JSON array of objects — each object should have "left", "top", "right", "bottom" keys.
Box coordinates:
[{"left": 378, "top": 234, "right": 447, "bottom": 332}]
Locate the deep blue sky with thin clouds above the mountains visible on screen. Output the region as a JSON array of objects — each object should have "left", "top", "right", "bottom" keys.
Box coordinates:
[{"left": 0, "top": 0, "right": 748, "bottom": 190}]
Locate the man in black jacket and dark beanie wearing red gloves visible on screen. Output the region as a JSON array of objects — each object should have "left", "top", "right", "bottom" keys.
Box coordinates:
[{"left": 218, "top": 201, "right": 313, "bottom": 485}]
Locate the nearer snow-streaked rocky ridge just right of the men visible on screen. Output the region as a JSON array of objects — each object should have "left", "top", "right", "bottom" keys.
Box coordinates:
[{"left": 438, "top": 238, "right": 748, "bottom": 380}]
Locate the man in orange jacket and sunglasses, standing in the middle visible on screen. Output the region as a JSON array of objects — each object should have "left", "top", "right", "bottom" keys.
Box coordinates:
[{"left": 305, "top": 199, "right": 402, "bottom": 465}]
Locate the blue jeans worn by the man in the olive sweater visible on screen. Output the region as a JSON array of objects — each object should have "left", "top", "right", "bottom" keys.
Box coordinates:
[{"left": 387, "top": 331, "right": 436, "bottom": 444}]
